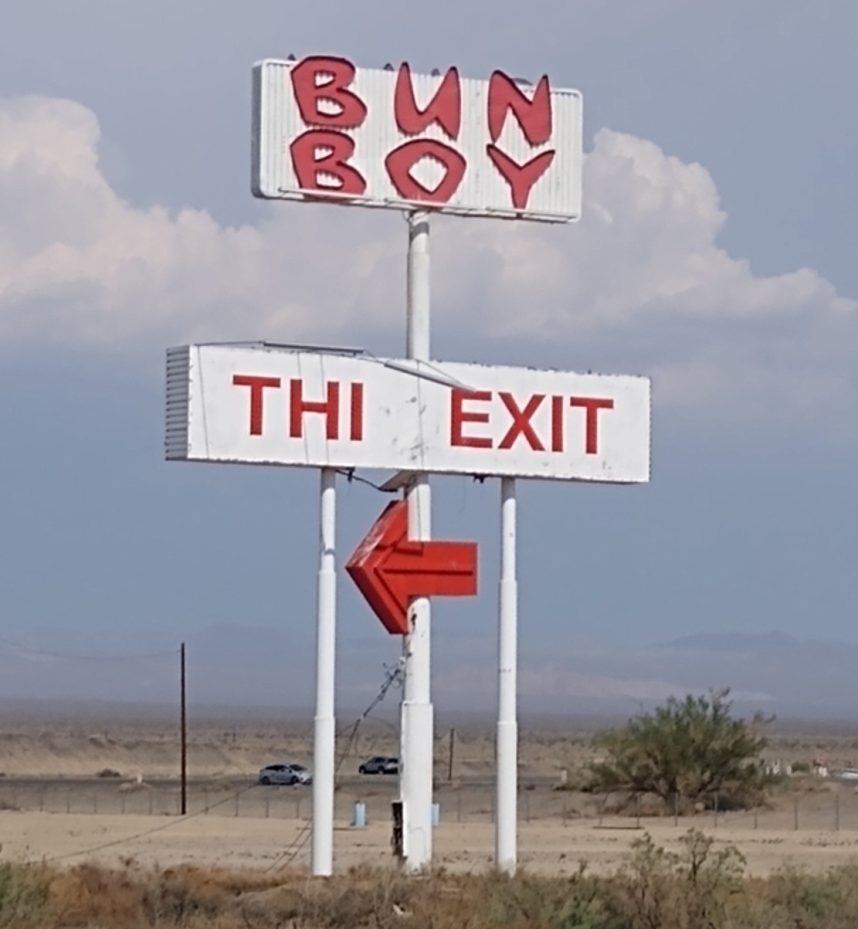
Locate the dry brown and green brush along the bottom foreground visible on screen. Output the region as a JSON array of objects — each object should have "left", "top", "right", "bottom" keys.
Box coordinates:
[{"left": 5, "top": 831, "right": 858, "bottom": 929}]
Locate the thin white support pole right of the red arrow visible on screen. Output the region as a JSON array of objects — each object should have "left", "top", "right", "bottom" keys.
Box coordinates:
[{"left": 495, "top": 477, "right": 518, "bottom": 874}]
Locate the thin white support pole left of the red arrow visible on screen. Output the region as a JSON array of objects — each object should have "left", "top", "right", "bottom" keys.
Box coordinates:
[{"left": 312, "top": 468, "right": 337, "bottom": 877}]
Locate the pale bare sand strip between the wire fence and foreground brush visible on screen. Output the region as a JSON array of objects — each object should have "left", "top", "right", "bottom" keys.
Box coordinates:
[{"left": 0, "top": 812, "right": 858, "bottom": 875}]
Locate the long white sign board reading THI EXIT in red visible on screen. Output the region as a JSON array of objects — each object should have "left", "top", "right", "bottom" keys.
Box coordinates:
[{"left": 166, "top": 344, "right": 650, "bottom": 483}]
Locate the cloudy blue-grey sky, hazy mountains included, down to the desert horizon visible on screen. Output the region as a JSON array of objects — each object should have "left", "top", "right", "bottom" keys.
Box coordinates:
[{"left": 0, "top": 0, "right": 858, "bottom": 715}]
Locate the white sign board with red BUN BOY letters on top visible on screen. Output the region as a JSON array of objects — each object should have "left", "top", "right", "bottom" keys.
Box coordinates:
[{"left": 252, "top": 55, "right": 583, "bottom": 222}]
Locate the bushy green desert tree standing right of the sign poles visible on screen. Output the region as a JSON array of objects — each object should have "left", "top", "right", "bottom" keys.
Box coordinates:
[{"left": 590, "top": 690, "right": 769, "bottom": 808}]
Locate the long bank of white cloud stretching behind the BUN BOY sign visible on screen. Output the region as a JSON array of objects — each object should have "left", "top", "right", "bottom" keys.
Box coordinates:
[{"left": 0, "top": 92, "right": 858, "bottom": 415}]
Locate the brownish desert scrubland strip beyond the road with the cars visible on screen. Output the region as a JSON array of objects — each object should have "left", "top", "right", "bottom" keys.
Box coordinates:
[{"left": 0, "top": 715, "right": 858, "bottom": 784}]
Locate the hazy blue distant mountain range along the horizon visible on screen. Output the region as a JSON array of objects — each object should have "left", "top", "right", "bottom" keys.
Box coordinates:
[{"left": 0, "top": 625, "right": 858, "bottom": 720}]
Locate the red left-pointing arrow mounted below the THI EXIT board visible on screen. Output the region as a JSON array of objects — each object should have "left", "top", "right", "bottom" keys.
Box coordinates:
[{"left": 346, "top": 500, "right": 477, "bottom": 635}]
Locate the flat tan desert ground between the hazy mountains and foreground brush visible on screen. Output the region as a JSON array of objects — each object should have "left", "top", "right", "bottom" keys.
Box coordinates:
[{"left": 0, "top": 717, "right": 858, "bottom": 875}]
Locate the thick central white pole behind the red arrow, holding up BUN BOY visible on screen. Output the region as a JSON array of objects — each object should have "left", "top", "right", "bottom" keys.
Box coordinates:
[{"left": 400, "top": 211, "right": 434, "bottom": 871}]
